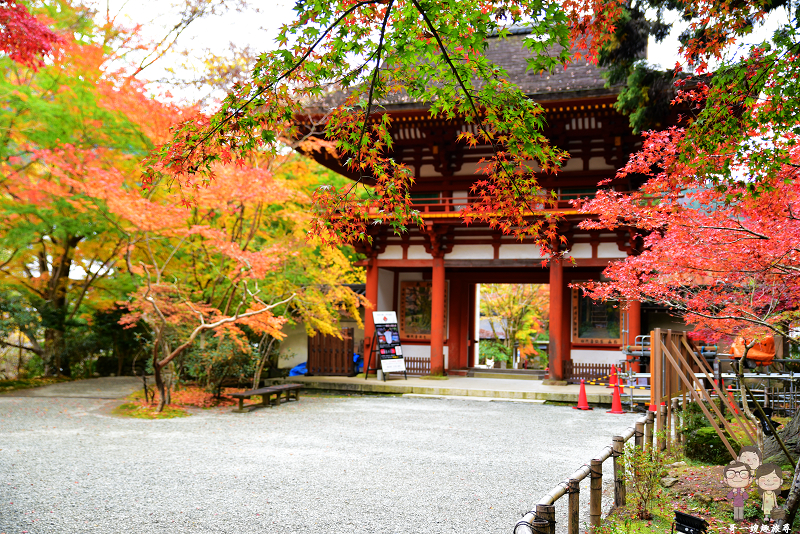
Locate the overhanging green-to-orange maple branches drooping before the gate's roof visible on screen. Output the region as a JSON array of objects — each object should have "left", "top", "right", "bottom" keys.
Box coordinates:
[{"left": 145, "top": 0, "right": 620, "bottom": 251}]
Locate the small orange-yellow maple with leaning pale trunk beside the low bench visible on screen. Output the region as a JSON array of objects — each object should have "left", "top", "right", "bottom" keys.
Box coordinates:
[{"left": 123, "top": 156, "right": 361, "bottom": 409}]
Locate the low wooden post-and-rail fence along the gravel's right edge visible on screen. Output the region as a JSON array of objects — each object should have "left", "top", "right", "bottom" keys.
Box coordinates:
[{"left": 514, "top": 412, "right": 655, "bottom": 534}]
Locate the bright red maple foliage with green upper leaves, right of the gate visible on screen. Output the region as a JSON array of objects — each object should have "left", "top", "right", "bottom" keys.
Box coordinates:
[{"left": 572, "top": 2, "right": 800, "bottom": 524}]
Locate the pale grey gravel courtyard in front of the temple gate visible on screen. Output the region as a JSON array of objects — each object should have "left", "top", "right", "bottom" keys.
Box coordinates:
[{"left": 0, "top": 395, "right": 636, "bottom": 534}]
